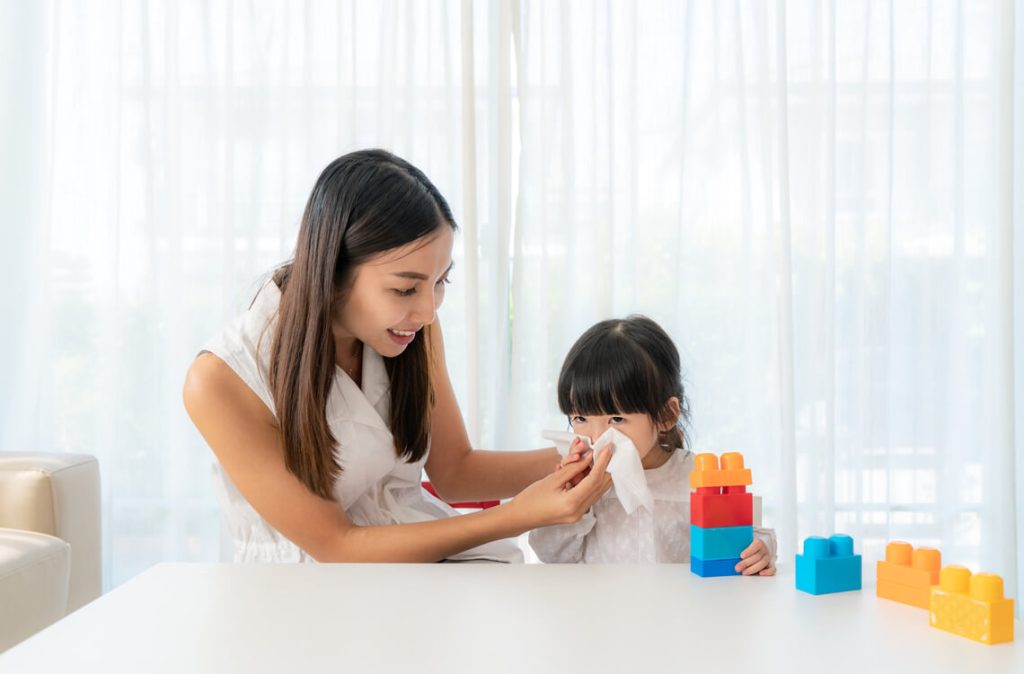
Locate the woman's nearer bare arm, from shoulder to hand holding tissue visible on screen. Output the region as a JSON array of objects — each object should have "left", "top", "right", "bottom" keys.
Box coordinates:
[{"left": 183, "top": 353, "right": 610, "bottom": 561}]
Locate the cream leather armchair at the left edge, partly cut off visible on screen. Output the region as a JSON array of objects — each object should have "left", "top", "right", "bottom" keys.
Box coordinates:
[{"left": 0, "top": 452, "right": 102, "bottom": 651}]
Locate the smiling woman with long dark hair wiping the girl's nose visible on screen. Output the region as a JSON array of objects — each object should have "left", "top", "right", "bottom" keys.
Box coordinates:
[{"left": 183, "top": 150, "right": 611, "bottom": 561}]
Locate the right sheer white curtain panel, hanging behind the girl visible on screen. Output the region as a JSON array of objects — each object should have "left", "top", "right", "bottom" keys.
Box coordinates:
[{"left": 507, "top": 0, "right": 1024, "bottom": 588}]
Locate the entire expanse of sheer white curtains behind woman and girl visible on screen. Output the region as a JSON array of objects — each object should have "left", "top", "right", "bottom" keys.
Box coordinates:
[{"left": 0, "top": 0, "right": 1024, "bottom": 593}]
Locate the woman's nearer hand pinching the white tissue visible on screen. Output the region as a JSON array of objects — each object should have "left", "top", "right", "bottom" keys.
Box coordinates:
[{"left": 509, "top": 448, "right": 611, "bottom": 530}]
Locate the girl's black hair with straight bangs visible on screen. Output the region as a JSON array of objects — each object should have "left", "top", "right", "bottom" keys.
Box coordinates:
[{"left": 558, "top": 314, "right": 690, "bottom": 452}]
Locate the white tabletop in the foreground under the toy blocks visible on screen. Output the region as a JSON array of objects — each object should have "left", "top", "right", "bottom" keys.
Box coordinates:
[{"left": 0, "top": 564, "right": 1024, "bottom": 674}]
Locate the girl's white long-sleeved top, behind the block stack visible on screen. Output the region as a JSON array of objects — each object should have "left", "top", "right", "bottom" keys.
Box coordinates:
[{"left": 529, "top": 450, "right": 776, "bottom": 563}]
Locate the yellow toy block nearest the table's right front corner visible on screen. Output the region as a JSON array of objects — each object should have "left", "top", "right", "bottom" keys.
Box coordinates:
[{"left": 928, "top": 566, "right": 1014, "bottom": 644}]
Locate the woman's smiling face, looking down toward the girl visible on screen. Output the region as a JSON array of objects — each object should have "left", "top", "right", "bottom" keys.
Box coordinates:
[{"left": 332, "top": 224, "right": 455, "bottom": 357}]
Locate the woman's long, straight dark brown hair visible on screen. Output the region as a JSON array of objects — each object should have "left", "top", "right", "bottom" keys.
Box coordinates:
[{"left": 268, "top": 150, "right": 456, "bottom": 498}]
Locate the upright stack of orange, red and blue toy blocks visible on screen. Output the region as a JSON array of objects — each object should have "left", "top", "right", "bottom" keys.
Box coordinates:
[{"left": 690, "top": 452, "right": 754, "bottom": 578}]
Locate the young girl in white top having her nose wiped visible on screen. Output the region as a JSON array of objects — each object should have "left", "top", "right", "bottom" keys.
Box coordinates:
[{"left": 529, "top": 315, "right": 775, "bottom": 576}]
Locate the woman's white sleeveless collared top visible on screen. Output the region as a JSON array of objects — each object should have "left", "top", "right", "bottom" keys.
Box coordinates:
[{"left": 203, "top": 281, "right": 522, "bottom": 562}]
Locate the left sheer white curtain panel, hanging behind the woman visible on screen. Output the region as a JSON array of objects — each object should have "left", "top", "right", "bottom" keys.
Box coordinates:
[{"left": 0, "top": 0, "right": 511, "bottom": 587}]
